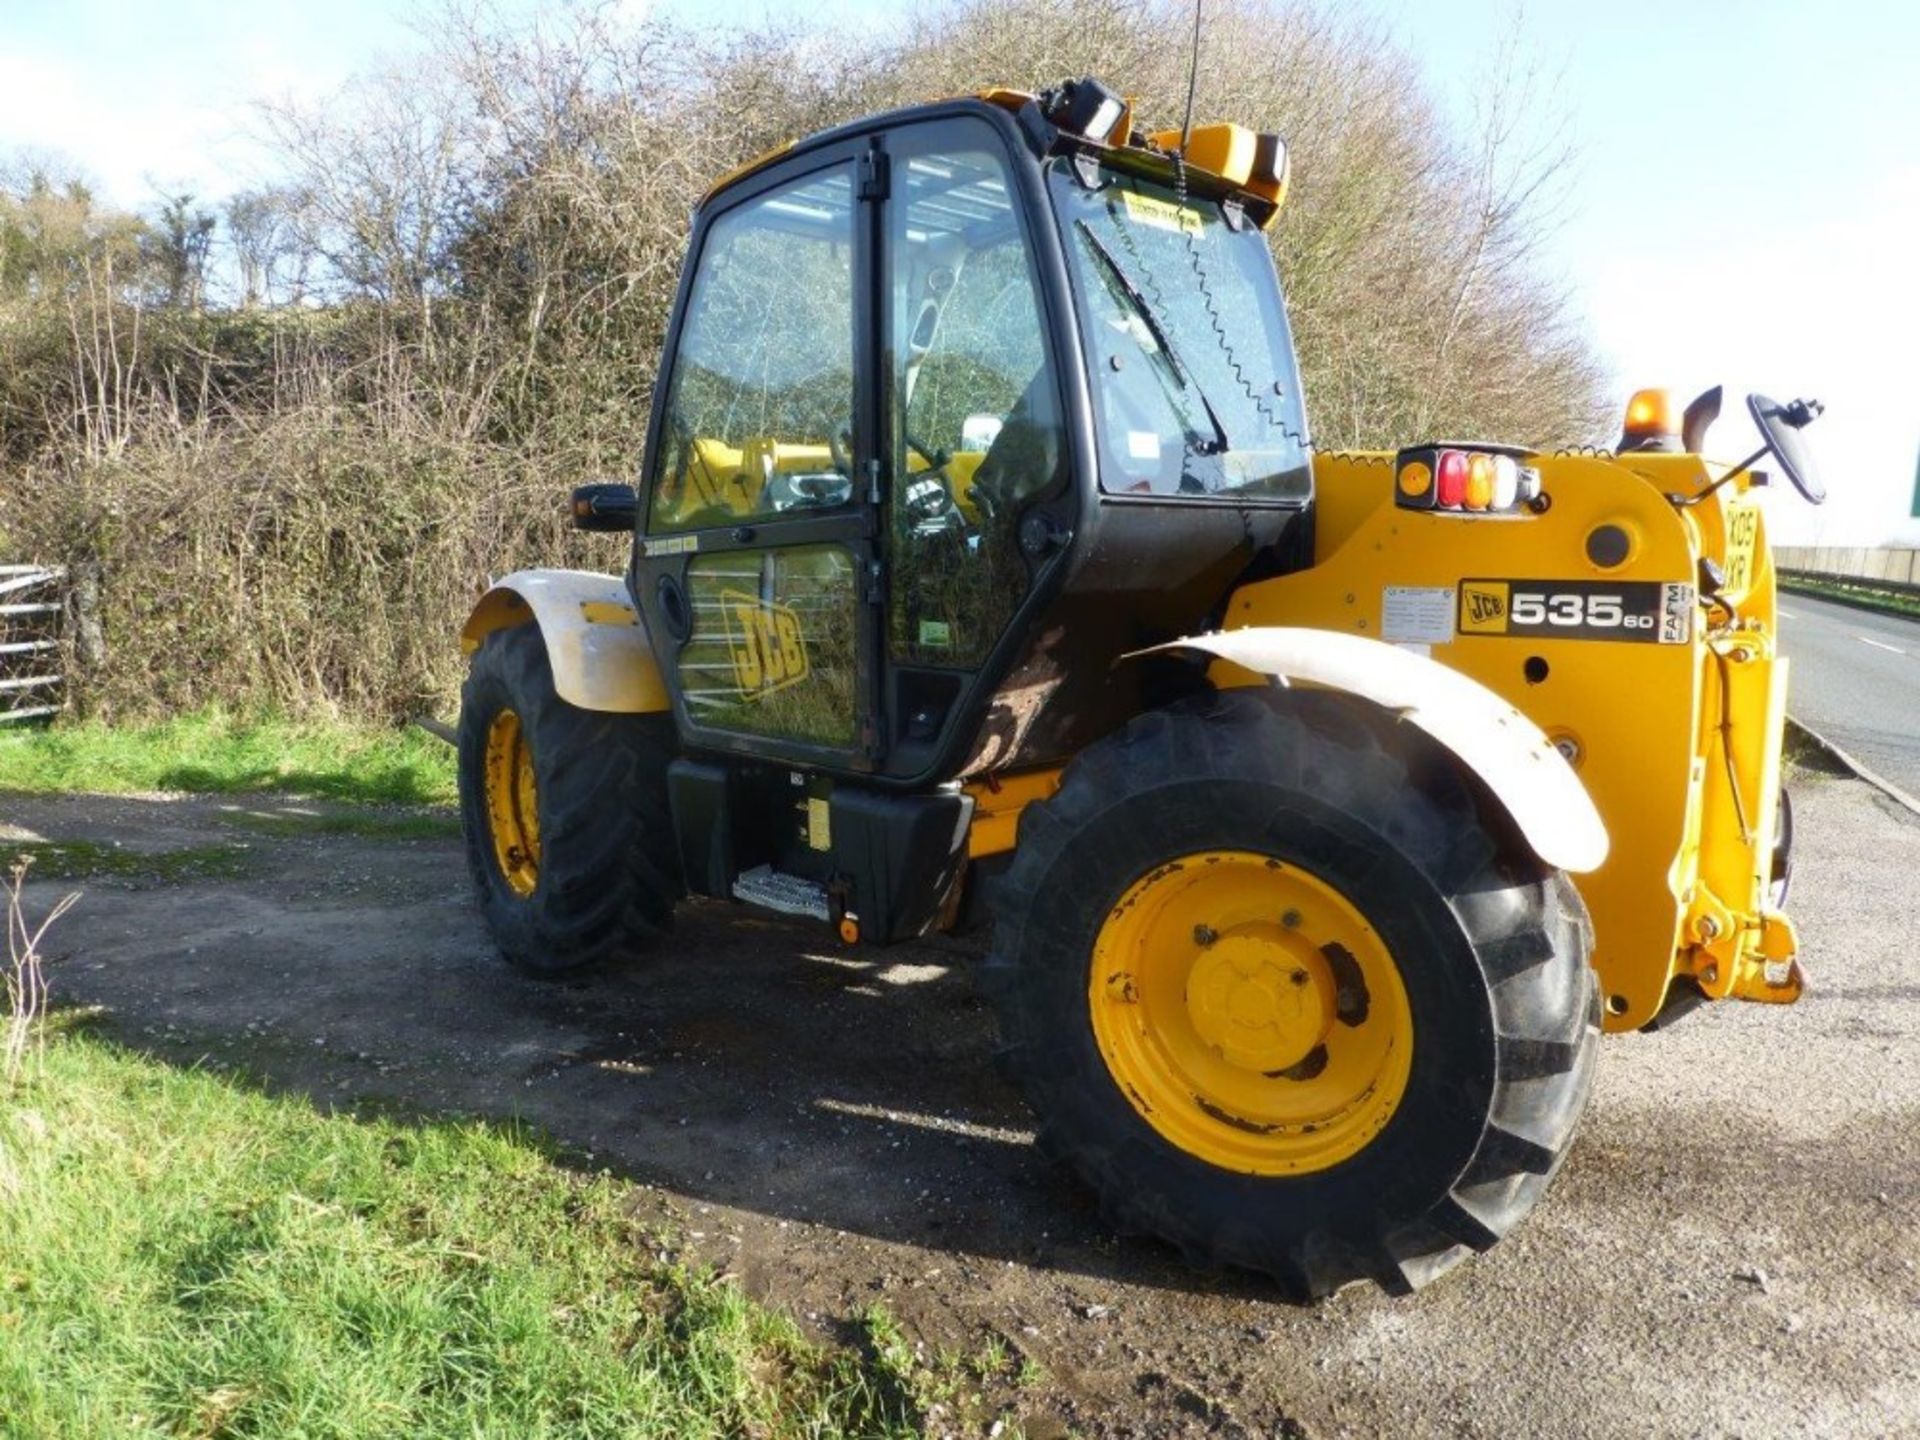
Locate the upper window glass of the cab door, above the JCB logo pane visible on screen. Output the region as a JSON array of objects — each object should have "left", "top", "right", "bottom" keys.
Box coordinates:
[{"left": 647, "top": 165, "right": 854, "bottom": 534}]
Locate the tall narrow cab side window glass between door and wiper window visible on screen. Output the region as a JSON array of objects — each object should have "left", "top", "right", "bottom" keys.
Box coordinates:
[{"left": 887, "top": 135, "right": 1062, "bottom": 668}]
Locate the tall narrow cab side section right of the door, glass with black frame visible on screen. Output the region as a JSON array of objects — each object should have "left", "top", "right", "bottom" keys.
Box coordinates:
[{"left": 881, "top": 113, "right": 1068, "bottom": 776}]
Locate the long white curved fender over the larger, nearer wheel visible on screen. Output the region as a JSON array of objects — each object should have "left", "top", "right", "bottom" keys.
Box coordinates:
[{"left": 1137, "top": 626, "right": 1607, "bottom": 872}]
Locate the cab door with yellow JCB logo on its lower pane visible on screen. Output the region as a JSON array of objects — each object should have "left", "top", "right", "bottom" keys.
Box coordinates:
[{"left": 634, "top": 142, "right": 881, "bottom": 770}]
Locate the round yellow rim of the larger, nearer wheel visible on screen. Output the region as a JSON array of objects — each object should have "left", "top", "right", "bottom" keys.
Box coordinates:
[{"left": 1089, "top": 851, "right": 1413, "bottom": 1175}]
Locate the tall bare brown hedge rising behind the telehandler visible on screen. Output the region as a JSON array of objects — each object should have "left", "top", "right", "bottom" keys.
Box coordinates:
[{"left": 0, "top": 0, "right": 1599, "bottom": 716}]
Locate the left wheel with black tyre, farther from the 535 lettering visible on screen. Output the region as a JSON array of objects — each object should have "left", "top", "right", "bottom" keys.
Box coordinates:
[{"left": 459, "top": 624, "right": 682, "bottom": 977}]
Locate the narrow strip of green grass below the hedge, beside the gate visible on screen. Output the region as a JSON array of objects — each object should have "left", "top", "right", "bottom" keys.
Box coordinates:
[{"left": 0, "top": 710, "right": 455, "bottom": 804}]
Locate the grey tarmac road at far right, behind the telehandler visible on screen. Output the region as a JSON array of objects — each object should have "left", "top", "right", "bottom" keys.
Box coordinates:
[{"left": 1780, "top": 591, "right": 1920, "bottom": 795}]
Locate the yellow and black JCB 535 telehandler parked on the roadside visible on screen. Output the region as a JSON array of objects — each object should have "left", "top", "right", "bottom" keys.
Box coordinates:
[{"left": 459, "top": 81, "right": 1814, "bottom": 1296}]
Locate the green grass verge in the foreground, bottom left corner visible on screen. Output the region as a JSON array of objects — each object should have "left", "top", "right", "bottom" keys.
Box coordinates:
[{"left": 0, "top": 1033, "right": 918, "bottom": 1440}]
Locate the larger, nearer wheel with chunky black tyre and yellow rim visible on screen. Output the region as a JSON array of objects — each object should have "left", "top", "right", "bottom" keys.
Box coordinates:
[{"left": 983, "top": 691, "right": 1599, "bottom": 1300}]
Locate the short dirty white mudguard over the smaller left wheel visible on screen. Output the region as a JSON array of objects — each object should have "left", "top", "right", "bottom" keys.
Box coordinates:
[{"left": 461, "top": 570, "right": 672, "bottom": 714}]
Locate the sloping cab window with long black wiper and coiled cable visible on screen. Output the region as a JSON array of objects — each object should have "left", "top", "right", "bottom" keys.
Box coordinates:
[{"left": 1048, "top": 163, "right": 1311, "bottom": 499}]
